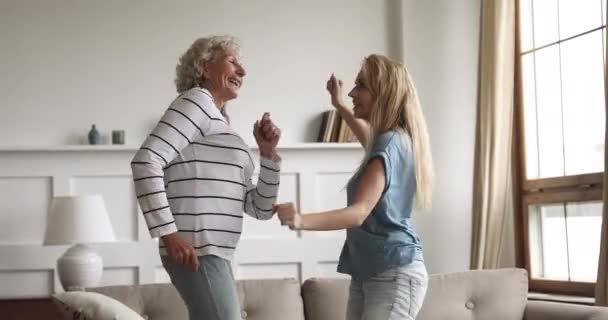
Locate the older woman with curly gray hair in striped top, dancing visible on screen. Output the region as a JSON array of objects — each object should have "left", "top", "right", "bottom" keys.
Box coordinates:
[{"left": 131, "top": 36, "right": 280, "bottom": 320}]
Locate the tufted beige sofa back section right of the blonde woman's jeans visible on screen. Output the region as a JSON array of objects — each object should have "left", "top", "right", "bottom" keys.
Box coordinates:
[{"left": 417, "top": 269, "right": 528, "bottom": 320}]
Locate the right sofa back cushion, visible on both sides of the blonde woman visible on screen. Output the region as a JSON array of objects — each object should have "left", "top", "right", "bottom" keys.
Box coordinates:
[{"left": 302, "top": 269, "right": 528, "bottom": 320}]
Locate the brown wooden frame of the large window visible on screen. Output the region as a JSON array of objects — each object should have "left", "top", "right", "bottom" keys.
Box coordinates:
[{"left": 511, "top": 0, "right": 608, "bottom": 297}]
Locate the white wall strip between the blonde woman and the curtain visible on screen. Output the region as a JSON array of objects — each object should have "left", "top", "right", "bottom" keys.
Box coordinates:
[{"left": 403, "top": 0, "right": 480, "bottom": 272}]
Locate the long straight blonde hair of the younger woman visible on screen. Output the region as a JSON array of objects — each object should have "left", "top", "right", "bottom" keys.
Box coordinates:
[{"left": 361, "top": 54, "right": 434, "bottom": 209}]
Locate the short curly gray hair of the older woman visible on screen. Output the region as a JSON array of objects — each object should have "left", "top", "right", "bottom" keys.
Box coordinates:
[{"left": 175, "top": 36, "right": 241, "bottom": 93}]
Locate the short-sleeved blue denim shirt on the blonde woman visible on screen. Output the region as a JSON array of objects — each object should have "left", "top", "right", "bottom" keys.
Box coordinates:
[{"left": 338, "top": 131, "right": 423, "bottom": 280}]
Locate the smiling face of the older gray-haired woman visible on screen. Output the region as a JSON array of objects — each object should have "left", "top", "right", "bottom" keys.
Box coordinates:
[{"left": 202, "top": 50, "right": 247, "bottom": 107}]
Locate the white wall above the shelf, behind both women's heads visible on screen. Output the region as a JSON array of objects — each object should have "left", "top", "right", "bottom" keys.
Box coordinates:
[{"left": 0, "top": 0, "right": 400, "bottom": 145}]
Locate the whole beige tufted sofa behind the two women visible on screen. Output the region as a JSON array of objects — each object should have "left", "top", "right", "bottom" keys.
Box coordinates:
[{"left": 87, "top": 269, "right": 608, "bottom": 320}]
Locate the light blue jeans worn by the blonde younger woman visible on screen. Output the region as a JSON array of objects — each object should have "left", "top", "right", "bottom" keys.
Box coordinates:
[{"left": 346, "top": 261, "right": 428, "bottom": 320}]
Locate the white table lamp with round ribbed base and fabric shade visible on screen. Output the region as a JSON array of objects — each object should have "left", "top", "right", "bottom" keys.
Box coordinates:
[{"left": 44, "top": 194, "right": 114, "bottom": 291}]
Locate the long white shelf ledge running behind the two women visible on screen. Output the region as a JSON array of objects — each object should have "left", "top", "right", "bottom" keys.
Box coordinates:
[{"left": 0, "top": 142, "right": 362, "bottom": 152}]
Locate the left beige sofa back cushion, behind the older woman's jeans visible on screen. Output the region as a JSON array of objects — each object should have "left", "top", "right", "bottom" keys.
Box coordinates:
[{"left": 87, "top": 279, "right": 304, "bottom": 320}]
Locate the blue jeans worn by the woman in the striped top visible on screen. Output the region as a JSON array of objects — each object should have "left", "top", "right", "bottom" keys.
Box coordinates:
[{"left": 161, "top": 255, "right": 241, "bottom": 320}]
